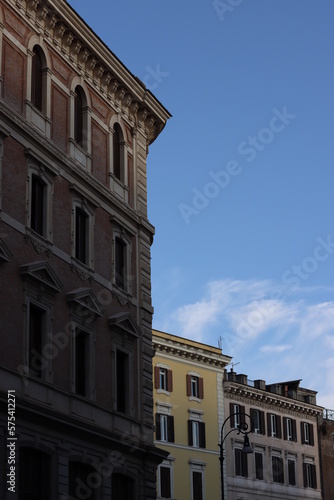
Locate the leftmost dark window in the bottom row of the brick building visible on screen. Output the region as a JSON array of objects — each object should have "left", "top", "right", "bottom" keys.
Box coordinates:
[{"left": 18, "top": 448, "right": 50, "bottom": 500}]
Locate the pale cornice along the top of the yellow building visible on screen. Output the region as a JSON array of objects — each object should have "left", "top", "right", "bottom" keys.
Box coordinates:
[{"left": 152, "top": 332, "right": 231, "bottom": 369}]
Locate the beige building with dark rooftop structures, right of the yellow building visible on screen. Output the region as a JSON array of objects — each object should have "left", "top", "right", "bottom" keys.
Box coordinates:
[{"left": 223, "top": 370, "right": 323, "bottom": 500}]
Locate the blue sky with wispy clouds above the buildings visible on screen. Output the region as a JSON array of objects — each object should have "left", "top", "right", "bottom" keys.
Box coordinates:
[{"left": 69, "top": 0, "right": 334, "bottom": 409}]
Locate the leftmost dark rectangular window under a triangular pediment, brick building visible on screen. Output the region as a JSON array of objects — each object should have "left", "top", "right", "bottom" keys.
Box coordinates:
[{"left": 29, "top": 304, "right": 46, "bottom": 378}]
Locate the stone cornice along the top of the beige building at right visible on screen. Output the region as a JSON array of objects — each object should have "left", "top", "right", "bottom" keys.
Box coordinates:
[{"left": 224, "top": 382, "right": 323, "bottom": 417}]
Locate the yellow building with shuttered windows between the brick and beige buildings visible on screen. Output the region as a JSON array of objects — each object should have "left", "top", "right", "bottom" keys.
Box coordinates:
[{"left": 153, "top": 330, "right": 231, "bottom": 500}]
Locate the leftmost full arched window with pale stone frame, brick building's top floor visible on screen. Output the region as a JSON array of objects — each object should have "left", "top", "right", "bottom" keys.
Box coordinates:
[{"left": 26, "top": 35, "right": 52, "bottom": 138}]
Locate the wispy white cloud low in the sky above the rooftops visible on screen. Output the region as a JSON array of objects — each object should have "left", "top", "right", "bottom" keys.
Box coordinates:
[{"left": 156, "top": 279, "right": 334, "bottom": 408}]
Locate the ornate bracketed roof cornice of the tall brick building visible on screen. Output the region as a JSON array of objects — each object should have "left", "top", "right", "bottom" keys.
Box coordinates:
[{"left": 6, "top": 0, "right": 171, "bottom": 144}]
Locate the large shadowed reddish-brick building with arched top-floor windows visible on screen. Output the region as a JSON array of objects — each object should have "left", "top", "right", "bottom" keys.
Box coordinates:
[{"left": 0, "top": 0, "right": 170, "bottom": 500}]
